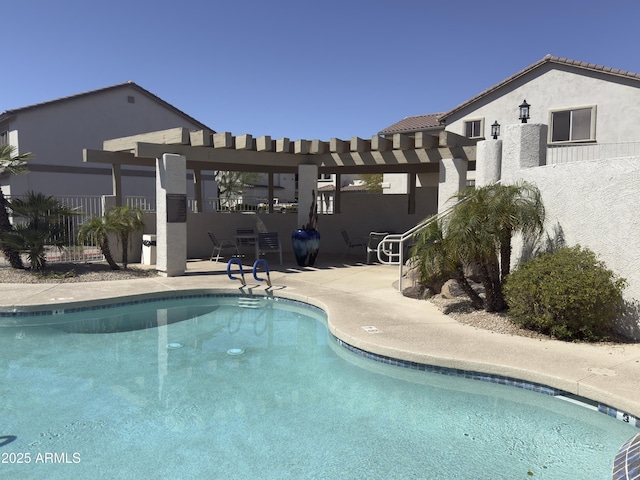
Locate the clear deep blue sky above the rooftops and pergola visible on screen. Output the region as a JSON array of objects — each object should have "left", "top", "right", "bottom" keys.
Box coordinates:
[{"left": 5, "top": 0, "right": 640, "bottom": 140}]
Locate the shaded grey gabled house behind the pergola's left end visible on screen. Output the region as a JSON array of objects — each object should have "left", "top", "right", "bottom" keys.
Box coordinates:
[{"left": 0, "top": 82, "right": 217, "bottom": 204}]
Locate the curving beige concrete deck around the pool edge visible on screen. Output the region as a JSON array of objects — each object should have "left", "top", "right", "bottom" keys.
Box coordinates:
[{"left": 0, "top": 256, "right": 640, "bottom": 423}]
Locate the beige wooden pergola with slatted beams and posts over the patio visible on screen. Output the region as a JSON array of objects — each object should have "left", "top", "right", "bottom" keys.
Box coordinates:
[{"left": 83, "top": 127, "right": 476, "bottom": 213}]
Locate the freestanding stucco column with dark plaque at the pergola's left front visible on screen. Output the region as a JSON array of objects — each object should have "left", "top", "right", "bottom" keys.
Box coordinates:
[{"left": 156, "top": 153, "right": 187, "bottom": 277}]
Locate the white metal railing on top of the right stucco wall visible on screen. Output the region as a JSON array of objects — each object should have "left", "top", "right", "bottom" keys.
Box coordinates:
[{"left": 547, "top": 142, "right": 640, "bottom": 165}]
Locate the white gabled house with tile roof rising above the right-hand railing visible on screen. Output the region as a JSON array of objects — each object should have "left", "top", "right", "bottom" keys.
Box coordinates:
[{"left": 439, "top": 55, "right": 640, "bottom": 146}]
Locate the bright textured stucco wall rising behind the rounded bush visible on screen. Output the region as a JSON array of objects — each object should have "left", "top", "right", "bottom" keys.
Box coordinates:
[{"left": 521, "top": 157, "right": 640, "bottom": 300}]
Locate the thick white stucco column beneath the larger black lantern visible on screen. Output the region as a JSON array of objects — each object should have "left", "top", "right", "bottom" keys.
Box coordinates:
[{"left": 501, "top": 123, "right": 547, "bottom": 183}]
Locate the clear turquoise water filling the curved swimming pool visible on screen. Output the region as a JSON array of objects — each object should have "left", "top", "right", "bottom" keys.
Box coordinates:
[{"left": 0, "top": 296, "right": 637, "bottom": 480}]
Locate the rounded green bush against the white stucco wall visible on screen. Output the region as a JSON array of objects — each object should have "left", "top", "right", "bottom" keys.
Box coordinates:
[{"left": 504, "top": 246, "right": 626, "bottom": 341}]
